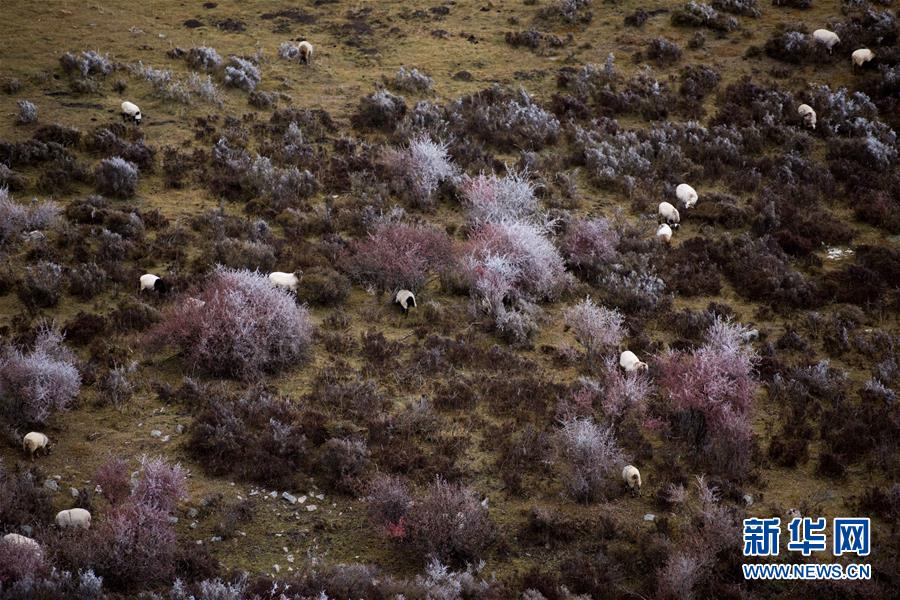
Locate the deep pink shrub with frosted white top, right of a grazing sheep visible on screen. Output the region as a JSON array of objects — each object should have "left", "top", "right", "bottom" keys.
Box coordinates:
[{"left": 659, "top": 319, "right": 757, "bottom": 477}]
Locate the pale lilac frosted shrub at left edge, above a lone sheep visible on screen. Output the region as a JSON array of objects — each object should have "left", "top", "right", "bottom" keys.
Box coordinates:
[{"left": 0, "top": 327, "right": 81, "bottom": 424}]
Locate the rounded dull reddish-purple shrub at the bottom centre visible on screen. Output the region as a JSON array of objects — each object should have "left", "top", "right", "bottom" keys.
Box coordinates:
[{"left": 406, "top": 477, "right": 495, "bottom": 562}]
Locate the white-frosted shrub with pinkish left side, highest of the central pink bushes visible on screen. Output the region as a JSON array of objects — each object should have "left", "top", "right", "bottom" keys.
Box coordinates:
[{"left": 384, "top": 135, "right": 459, "bottom": 206}]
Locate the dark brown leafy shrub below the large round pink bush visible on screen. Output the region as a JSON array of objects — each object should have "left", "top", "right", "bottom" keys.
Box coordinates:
[{"left": 188, "top": 387, "right": 307, "bottom": 486}]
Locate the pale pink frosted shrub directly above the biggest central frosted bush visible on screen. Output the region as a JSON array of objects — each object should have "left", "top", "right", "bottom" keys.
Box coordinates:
[{"left": 462, "top": 171, "right": 539, "bottom": 228}]
